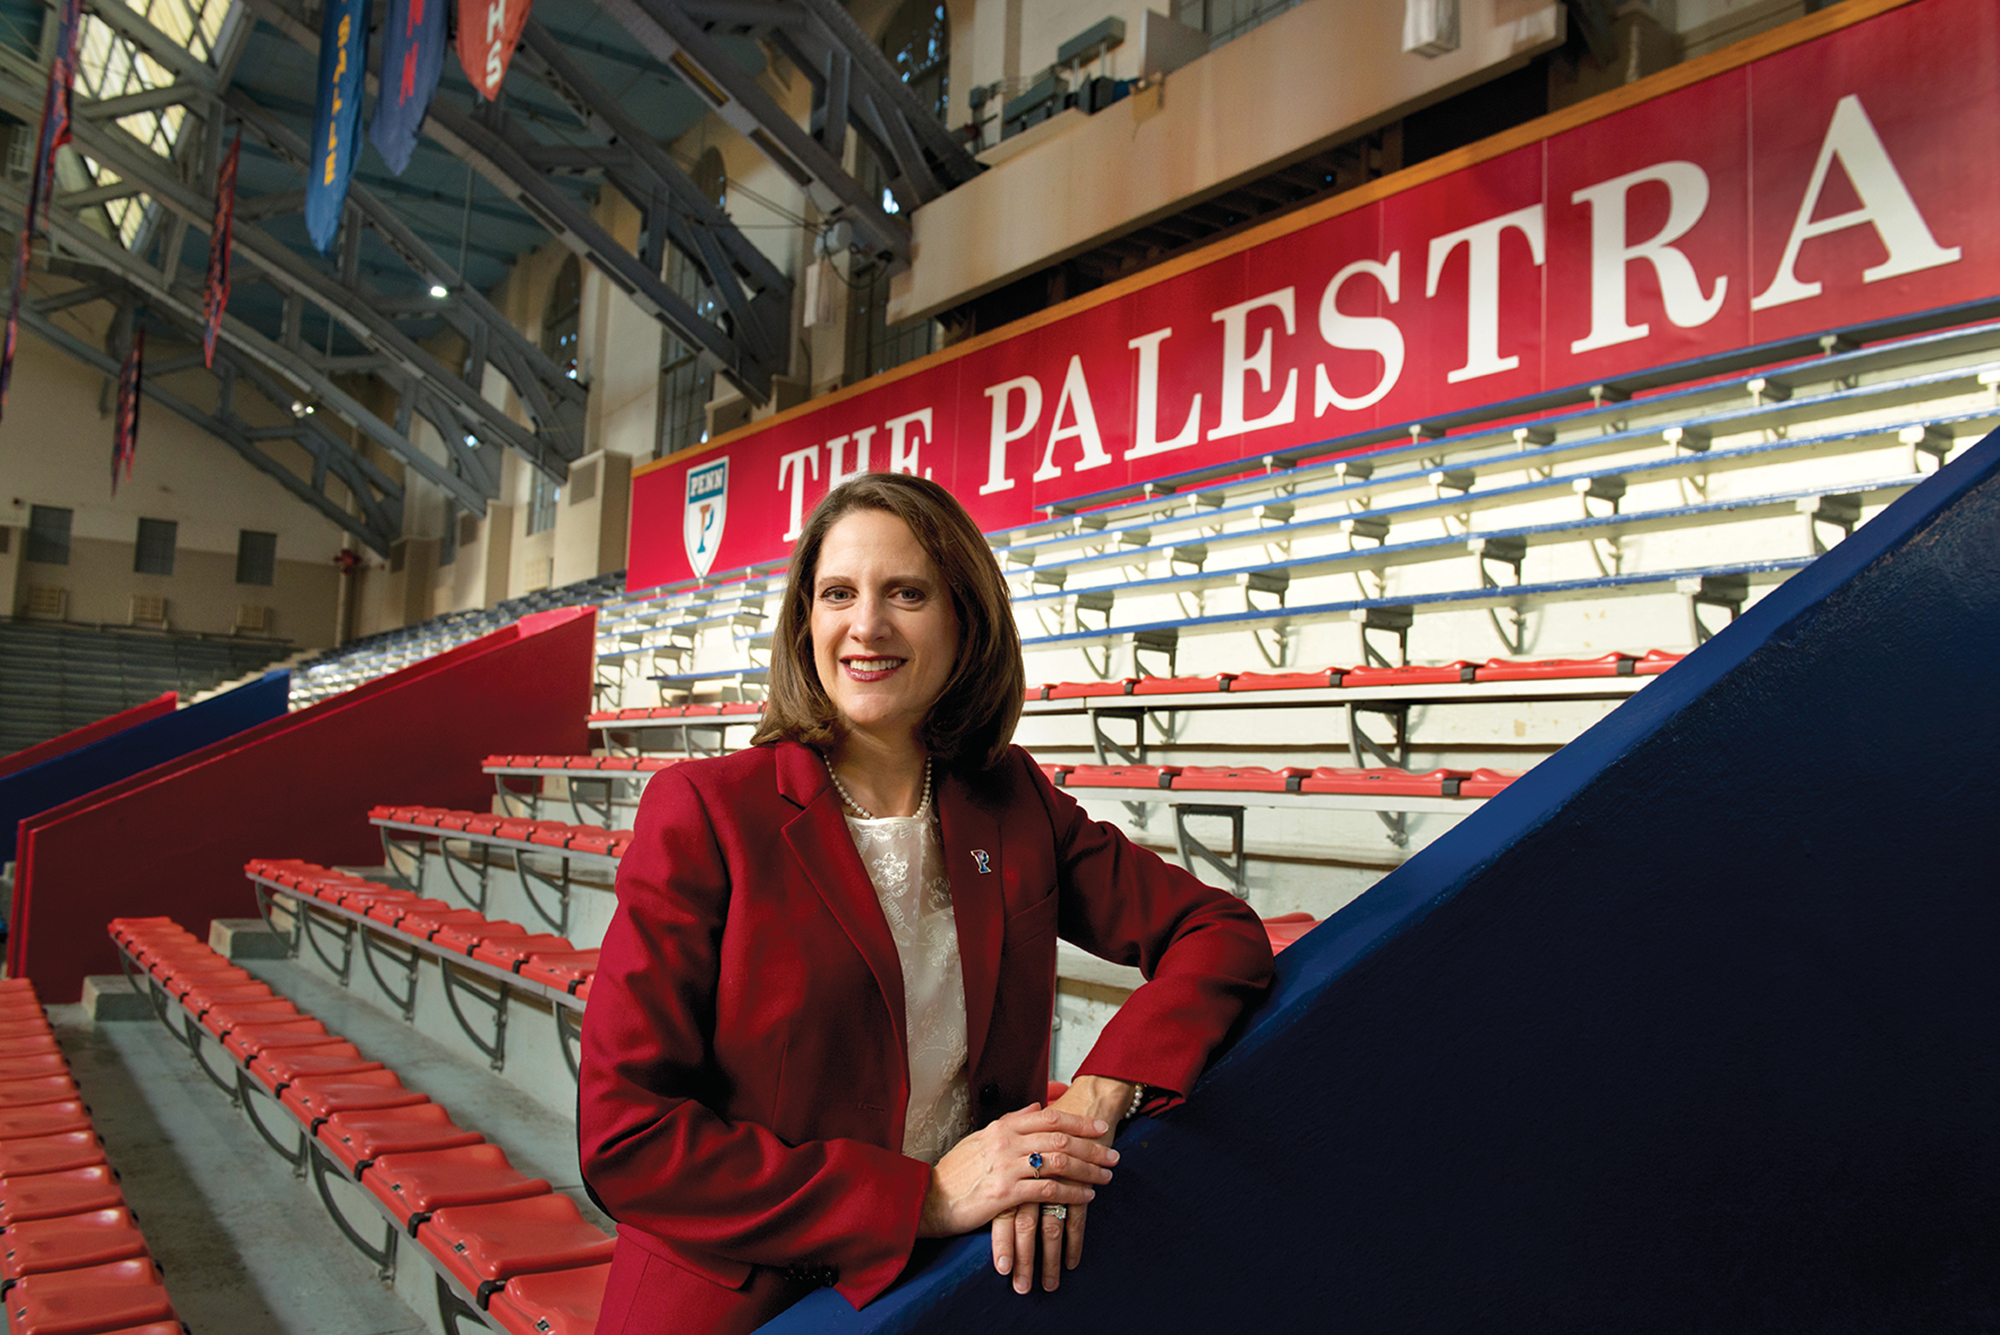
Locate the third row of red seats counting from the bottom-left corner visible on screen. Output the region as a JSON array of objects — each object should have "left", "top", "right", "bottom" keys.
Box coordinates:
[{"left": 244, "top": 857, "right": 598, "bottom": 997}]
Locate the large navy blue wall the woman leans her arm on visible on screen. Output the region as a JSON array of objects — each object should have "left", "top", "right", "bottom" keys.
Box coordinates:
[{"left": 766, "top": 434, "right": 2000, "bottom": 1335}]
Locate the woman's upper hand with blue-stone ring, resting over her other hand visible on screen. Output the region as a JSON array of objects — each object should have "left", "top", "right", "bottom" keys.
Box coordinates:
[{"left": 916, "top": 1103, "right": 1116, "bottom": 1239}]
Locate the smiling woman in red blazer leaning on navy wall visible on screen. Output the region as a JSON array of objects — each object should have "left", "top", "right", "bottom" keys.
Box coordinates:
[{"left": 578, "top": 474, "right": 1272, "bottom": 1333}]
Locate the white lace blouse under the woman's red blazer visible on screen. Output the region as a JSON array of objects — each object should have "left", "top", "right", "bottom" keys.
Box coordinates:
[{"left": 846, "top": 811, "right": 972, "bottom": 1163}]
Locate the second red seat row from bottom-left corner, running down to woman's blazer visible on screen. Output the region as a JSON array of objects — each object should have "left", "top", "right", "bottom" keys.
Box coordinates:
[{"left": 110, "top": 917, "right": 612, "bottom": 1335}]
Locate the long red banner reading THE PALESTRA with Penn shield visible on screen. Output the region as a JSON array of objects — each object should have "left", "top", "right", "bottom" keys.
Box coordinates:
[{"left": 628, "top": 0, "right": 2000, "bottom": 590}]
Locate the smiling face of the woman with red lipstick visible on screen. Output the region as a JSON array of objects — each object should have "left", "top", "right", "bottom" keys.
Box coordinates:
[{"left": 812, "top": 510, "right": 958, "bottom": 747}]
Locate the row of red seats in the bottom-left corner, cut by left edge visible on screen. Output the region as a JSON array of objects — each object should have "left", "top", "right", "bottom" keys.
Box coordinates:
[{"left": 0, "top": 979, "right": 182, "bottom": 1335}]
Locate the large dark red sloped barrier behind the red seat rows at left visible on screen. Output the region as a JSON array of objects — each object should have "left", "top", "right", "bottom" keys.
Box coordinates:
[{"left": 8, "top": 608, "right": 596, "bottom": 1001}]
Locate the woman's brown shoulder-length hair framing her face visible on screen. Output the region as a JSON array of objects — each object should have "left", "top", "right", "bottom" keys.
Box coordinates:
[{"left": 750, "top": 474, "right": 1026, "bottom": 773}]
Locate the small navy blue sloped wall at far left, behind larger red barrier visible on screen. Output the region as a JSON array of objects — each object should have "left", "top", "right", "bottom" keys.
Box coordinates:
[{"left": 0, "top": 671, "right": 292, "bottom": 871}]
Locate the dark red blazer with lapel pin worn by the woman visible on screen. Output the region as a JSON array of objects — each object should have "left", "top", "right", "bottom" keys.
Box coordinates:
[{"left": 578, "top": 741, "right": 1272, "bottom": 1331}]
